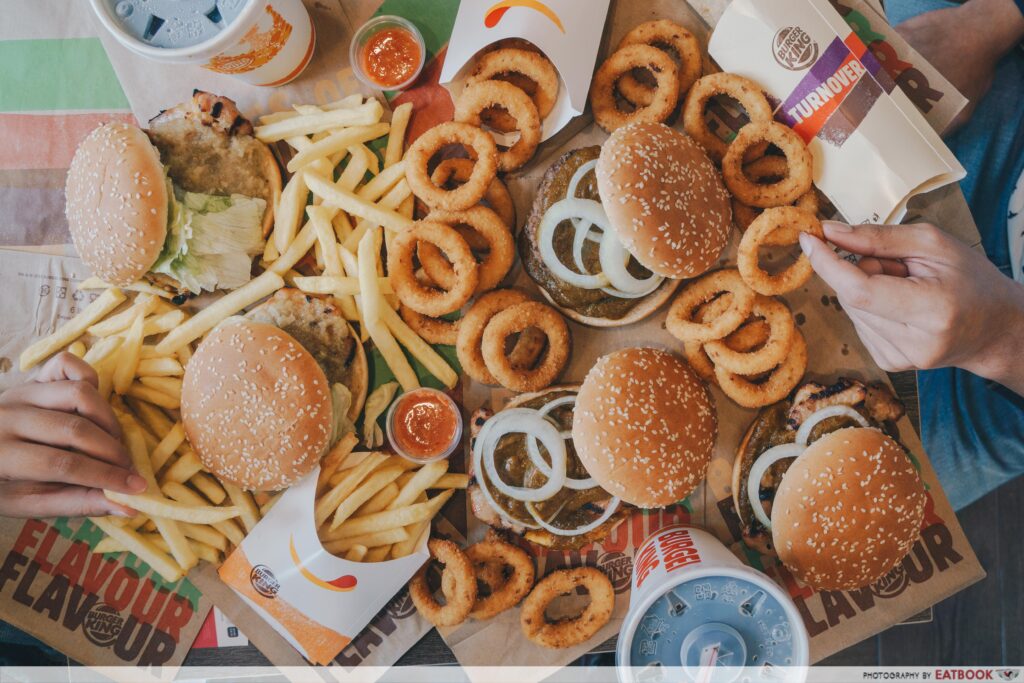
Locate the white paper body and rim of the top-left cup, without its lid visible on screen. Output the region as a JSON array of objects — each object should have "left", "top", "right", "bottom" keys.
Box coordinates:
[{"left": 90, "top": 0, "right": 316, "bottom": 86}]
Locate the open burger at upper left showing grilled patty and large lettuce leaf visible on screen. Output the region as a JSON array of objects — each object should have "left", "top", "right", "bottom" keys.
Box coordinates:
[{"left": 66, "top": 91, "right": 281, "bottom": 295}]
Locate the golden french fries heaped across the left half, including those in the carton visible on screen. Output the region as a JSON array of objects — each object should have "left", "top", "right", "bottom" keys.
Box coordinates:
[{"left": 19, "top": 95, "right": 468, "bottom": 582}]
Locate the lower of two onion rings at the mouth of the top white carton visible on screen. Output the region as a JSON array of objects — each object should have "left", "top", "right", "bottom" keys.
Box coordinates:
[{"left": 455, "top": 79, "right": 541, "bottom": 172}]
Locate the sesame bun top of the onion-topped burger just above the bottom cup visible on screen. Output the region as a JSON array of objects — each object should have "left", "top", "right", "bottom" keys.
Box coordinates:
[{"left": 572, "top": 348, "right": 718, "bottom": 508}]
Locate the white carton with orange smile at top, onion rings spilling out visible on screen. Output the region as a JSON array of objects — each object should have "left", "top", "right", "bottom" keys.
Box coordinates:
[{"left": 440, "top": 0, "right": 610, "bottom": 140}]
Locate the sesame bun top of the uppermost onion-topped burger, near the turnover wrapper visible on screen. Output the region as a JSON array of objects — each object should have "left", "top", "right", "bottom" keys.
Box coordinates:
[{"left": 597, "top": 123, "right": 732, "bottom": 279}]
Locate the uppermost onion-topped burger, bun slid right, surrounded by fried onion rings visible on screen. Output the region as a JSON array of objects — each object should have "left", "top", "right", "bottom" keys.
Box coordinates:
[{"left": 519, "top": 123, "right": 732, "bottom": 327}]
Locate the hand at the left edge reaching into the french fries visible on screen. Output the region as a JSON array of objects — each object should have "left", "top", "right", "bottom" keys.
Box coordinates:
[{"left": 0, "top": 352, "right": 146, "bottom": 517}]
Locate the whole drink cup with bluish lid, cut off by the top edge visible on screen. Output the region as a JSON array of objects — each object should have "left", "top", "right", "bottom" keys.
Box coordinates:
[{"left": 90, "top": 0, "right": 316, "bottom": 86}]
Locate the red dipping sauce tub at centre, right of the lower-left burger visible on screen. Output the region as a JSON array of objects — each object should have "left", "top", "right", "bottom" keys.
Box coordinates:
[{"left": 387, "top": 388, "right": 462, "bottom": 463}]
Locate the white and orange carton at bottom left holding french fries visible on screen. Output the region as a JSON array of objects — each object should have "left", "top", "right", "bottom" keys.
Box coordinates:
[{"left": 219, "top": 467, "right": 429, "bottom": 665}]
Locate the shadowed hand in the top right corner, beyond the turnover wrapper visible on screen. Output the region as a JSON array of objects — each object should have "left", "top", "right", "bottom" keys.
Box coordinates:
[{"left": 896, "top": 0, "right": 1024, "bottom": 133}]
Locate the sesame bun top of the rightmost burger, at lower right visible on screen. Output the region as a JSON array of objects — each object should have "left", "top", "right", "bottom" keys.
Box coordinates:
[{"left": 771, "top": 427, "right": 928, "bottom": 591}]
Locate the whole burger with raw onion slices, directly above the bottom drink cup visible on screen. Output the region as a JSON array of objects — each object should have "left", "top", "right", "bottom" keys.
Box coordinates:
[{"left": 469, "top": 348, "right": 717, "bottom": 549}]
